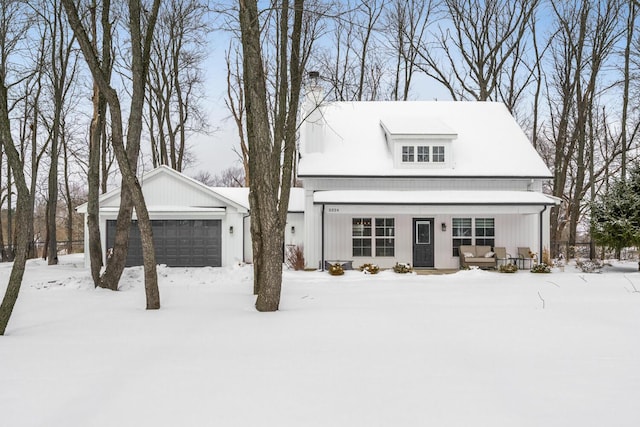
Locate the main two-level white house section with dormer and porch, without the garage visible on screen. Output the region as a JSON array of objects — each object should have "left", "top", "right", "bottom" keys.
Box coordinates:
[{"left": 298, "top": 87, "right": 555, "bottom": 269}]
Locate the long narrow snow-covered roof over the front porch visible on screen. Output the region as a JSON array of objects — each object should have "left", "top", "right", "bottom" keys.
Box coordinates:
[{"left": 313, "top": 190, "right": 558, "bottom": 206}]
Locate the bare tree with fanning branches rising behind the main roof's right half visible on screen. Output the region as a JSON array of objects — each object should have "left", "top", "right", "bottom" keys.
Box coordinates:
[{"left": 418, "top": 0, "right": 538, "bottom": 110}]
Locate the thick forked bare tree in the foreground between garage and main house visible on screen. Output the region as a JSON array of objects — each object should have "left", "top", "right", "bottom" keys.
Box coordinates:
[{"left": 239, "top": 0, "right": 312, "bottom": 311}]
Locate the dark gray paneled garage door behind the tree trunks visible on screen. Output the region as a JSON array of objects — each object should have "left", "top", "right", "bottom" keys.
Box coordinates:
[{"left": 107, "top": 219, "right": 222, "bottom": 267}]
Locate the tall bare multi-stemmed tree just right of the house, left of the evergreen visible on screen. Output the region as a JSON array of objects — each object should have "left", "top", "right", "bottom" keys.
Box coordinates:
[{"left": 547, "top": 0, "right": 621, "bottom": 255}]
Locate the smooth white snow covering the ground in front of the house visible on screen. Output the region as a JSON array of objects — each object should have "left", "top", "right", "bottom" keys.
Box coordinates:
[{"left": 0, "top": 256, "right": 640, "bottom": 427}]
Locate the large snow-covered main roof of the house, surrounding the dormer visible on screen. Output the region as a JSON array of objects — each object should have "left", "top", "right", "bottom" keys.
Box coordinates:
[{"left": 298, "top": 101, "right": 551, "bottom": 178}]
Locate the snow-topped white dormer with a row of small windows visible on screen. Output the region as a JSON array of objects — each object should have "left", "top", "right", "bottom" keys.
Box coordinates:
[{"left": 380, "top": 116, "right": 458, "bottom": 169}]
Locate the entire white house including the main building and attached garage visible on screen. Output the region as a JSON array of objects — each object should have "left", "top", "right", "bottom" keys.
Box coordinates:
[{"left": 78, "top": 96, "right": 556, "bottom": 269}]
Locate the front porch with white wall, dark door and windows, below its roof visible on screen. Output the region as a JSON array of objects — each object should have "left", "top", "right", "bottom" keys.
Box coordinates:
[{"left": 305, "top": 198, "right": 548, "bottom": 274}]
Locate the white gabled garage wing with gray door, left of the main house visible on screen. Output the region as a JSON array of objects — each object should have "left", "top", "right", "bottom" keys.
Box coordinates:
[{"left": 77, "top": 166, "right": 304, "bottom": 267}]
